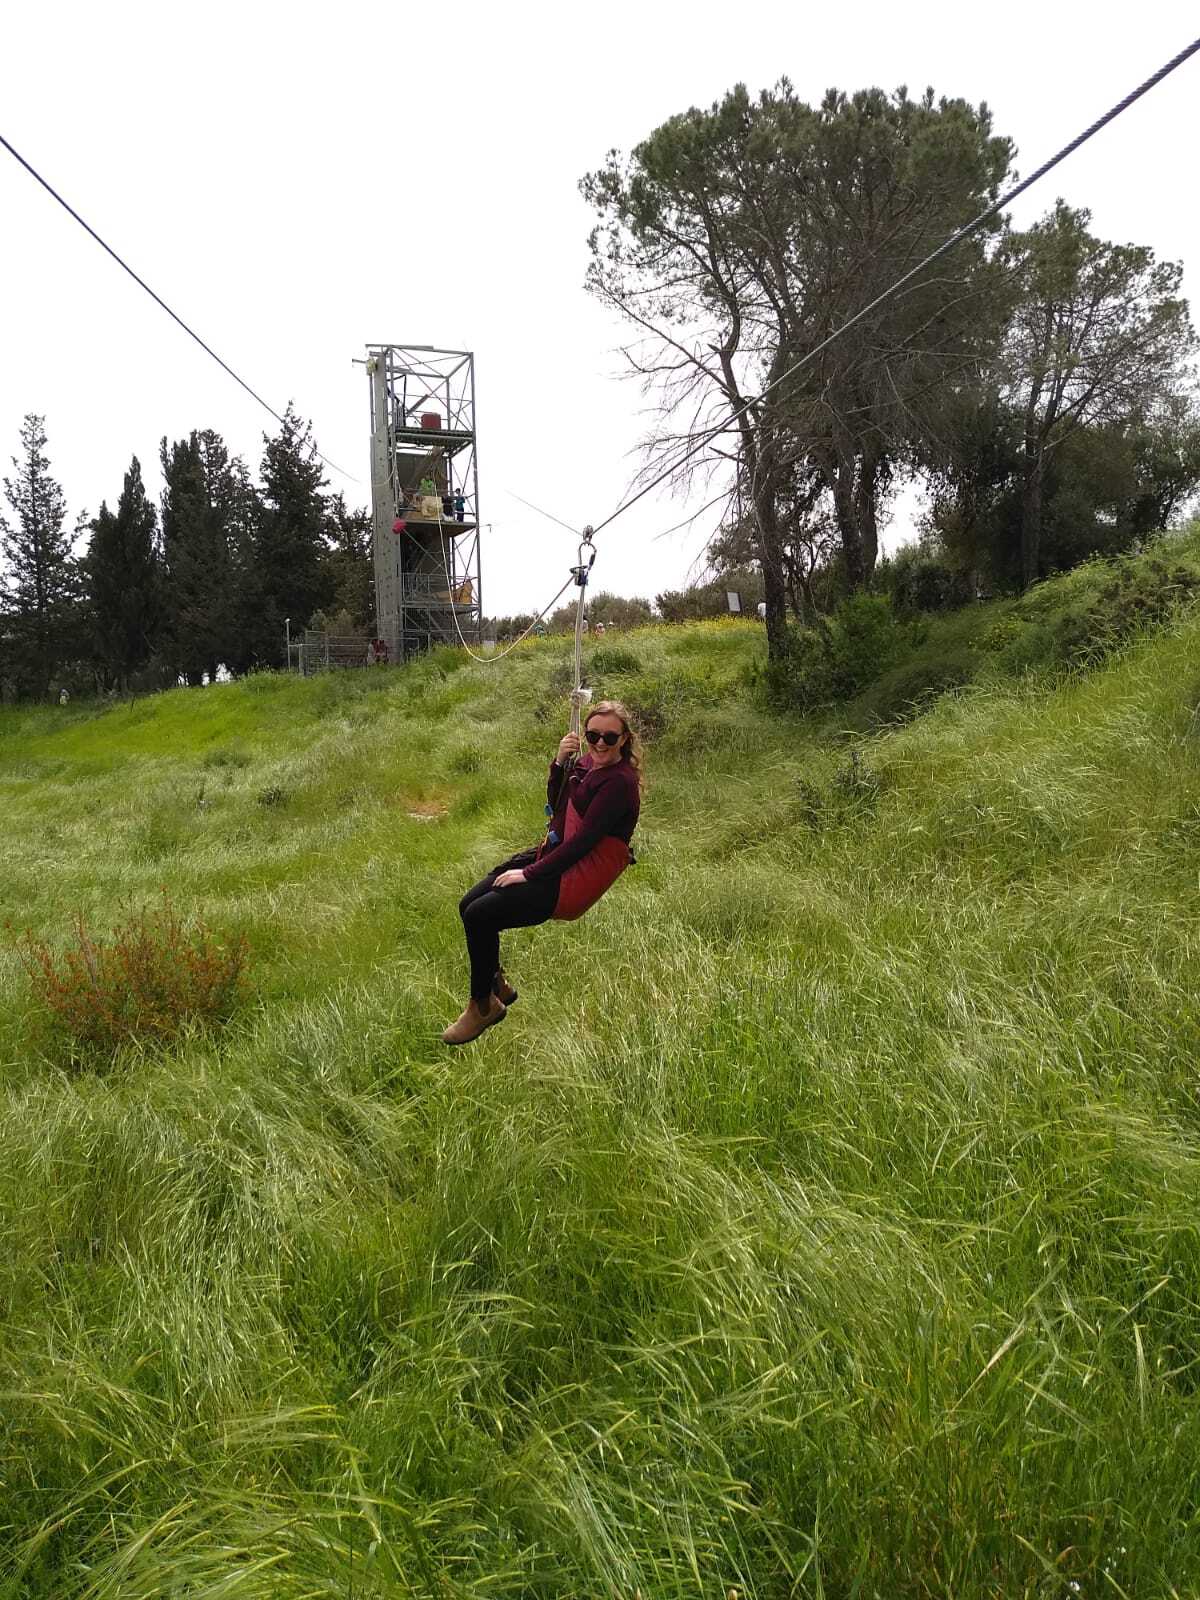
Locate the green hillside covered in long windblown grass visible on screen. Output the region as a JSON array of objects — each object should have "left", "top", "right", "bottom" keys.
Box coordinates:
[{"left": 0, "top": 553, "right": 1200, "bottom": 1600}]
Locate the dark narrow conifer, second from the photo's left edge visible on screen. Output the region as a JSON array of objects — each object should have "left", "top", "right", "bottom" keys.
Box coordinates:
[{"left": 83, "top": 456, "right": 163, "bottom": 688}]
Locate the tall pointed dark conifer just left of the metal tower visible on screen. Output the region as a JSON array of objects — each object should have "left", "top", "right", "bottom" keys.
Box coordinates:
[{"left": 256, "top": 405, "right": 334, "bottom": 667}]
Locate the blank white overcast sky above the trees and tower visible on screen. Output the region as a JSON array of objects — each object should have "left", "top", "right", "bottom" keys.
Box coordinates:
[{"left": 0, "top": 0, "right": 1200, "bottom": 614}]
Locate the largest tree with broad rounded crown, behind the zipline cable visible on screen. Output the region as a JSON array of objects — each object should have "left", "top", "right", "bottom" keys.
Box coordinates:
[{"left": 582, "top": 80, "right": 1011, "bottom": 648}]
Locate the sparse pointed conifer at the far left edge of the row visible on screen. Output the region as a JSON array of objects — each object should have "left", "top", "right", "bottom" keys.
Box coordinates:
[{"left": 0, "top": 411, "right": 82, "bottom": 696}]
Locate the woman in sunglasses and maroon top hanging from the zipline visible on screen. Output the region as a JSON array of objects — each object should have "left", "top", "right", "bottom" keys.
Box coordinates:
[{"left": 442, "top": 701, "right": 642, "bottom": 1045}]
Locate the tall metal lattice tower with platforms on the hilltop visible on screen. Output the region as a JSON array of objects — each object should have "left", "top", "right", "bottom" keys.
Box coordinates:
[{"left": 366, "top": 344, "right": 483, "bottom": 661}]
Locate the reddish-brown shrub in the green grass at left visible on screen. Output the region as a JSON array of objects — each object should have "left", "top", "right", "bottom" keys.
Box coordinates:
[{"left": 18, "top": 894, "right": 248, "bottom": 1056}]
